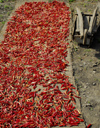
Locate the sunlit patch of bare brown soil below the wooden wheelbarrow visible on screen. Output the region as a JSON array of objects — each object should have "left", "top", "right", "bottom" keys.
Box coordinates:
[{"left": 72, "top": 28, "right": 100, "bottom": 128}]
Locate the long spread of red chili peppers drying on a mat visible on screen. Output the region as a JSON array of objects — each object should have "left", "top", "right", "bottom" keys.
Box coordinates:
[{"left": 0, "top": 1, "right": 83, "bottom": 128}]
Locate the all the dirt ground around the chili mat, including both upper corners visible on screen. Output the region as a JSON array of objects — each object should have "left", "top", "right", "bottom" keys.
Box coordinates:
[{"left": 0, "top": 0, "right": 100, "bottom": 128}]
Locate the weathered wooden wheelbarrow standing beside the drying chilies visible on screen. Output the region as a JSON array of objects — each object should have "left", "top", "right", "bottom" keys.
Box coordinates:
[{"left": 71, "top": 7, "right": 100, "bottom": 46}]
